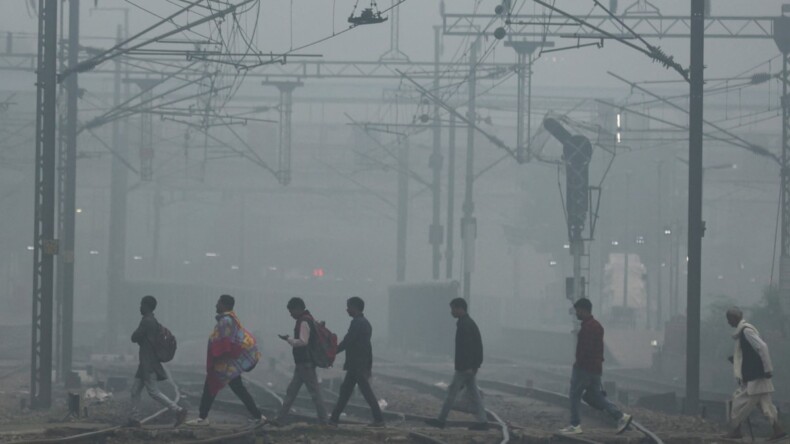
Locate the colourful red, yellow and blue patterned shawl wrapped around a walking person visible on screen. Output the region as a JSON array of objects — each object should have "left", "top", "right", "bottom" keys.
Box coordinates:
[{"left": 206, "top": 311, "right": 261, "bottom": 395}]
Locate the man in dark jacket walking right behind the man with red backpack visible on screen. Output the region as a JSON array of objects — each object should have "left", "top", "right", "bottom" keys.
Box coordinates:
[{"left": 329, "top": 296, "right": 385, "bottom": 427}]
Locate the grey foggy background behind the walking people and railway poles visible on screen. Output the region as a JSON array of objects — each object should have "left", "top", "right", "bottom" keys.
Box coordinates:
[{"left": 0, "top": 0, "right": 782, "bottom": 382}]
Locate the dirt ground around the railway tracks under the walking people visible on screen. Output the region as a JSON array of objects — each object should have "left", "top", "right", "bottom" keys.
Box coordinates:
[{"left": 0, "top": 360, "right": 785, "bottom": 444}]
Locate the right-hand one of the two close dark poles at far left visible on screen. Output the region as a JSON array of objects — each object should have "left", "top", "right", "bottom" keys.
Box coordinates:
[{"left": 58, "top": 0, "right": 80, "bottom": 381}]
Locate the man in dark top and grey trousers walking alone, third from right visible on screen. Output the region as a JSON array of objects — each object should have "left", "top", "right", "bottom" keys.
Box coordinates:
[{"left": 426, "top": 298, "right": 488, "bottom": 430}]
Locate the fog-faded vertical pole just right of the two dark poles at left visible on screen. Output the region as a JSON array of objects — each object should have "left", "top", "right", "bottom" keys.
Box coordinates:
[{"left": 107, "top": 26, "right": 128, "bottom": 351}]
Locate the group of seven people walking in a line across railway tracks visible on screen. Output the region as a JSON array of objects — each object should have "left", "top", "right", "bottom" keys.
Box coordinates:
[{"left": 132, "top": 295, "right": 787, "bottom": 439}]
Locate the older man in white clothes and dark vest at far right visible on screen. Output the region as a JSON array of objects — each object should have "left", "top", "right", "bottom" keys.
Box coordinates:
[{"left": 726, "top": 307, "right": 787, "bottom": 440}]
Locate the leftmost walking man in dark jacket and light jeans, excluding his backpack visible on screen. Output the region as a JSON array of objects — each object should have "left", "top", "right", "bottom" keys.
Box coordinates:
[{"left": 132, "top": 295, "right": 187, "bottom": 427}]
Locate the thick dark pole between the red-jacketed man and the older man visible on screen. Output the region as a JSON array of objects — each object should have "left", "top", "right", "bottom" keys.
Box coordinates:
[{"left": 685, "top": 0, "right": 705, "bottom": 415}]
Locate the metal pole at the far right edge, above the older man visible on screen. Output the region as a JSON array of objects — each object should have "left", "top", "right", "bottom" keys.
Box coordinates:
[{"left": 773, "top": 5, "right": 790, "bottom": 326}]
